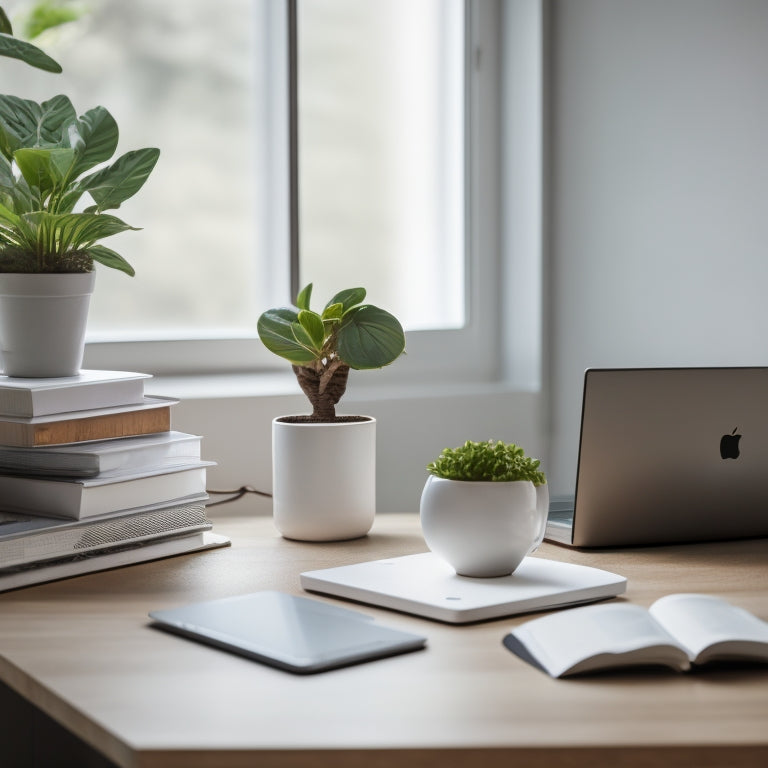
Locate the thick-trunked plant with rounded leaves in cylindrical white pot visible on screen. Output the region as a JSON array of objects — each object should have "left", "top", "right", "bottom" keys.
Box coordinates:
[{"left": 258, "top": 283, "right": 405, "bottom": 541}]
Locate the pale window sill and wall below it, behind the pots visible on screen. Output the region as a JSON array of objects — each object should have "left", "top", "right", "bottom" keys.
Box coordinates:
[{"left": 147, "top": 371, "right": 546, "bottom": 514}]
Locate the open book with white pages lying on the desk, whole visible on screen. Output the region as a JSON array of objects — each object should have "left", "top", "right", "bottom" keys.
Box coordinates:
[{"left": 504, "top": 594, "right": 768, "bottom": 677}]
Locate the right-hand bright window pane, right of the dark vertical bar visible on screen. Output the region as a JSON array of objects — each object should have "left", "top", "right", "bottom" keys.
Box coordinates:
[{"left": 298, "top": 0, "right": 465, "bottom": 330}]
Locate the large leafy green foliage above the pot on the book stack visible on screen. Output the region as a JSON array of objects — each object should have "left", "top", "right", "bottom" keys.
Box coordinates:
[{"left": 0, "top": 95, "right": 160, "bottom": 275}]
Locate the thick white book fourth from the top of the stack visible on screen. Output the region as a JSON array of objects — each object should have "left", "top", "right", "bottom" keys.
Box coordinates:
[{"left": 0, "top": 461, "right": 214, "bottom": 520}]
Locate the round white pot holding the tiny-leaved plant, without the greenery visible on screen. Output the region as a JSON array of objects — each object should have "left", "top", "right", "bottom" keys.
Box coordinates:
[{"left": 420, "top": 475, "right": 549, "bottom": 578}]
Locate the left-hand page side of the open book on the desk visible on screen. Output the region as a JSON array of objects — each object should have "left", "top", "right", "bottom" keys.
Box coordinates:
[{"left": 511, "top": 603, "right": 687, "bottom": 677}]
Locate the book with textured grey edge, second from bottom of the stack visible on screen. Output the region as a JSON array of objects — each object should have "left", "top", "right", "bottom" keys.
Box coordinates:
[{"left": 0, "top": 497, "right": 211, "bottom": 573}]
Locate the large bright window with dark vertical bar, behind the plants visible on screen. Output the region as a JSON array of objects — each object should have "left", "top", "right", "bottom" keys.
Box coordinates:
[{"left": 5, "top": 0, "right": 498, "bottom": 378}]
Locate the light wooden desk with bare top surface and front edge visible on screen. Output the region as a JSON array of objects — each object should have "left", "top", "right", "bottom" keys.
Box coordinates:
[{"left": 0, "top": 513, "right": 768, "bottom": 768}]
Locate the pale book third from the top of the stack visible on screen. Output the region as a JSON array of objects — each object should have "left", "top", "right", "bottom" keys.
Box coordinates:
[{"left": 0, "top": 431, "right": 202, "bottom": 477}]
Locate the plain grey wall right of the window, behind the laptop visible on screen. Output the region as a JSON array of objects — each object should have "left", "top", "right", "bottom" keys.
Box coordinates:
[{"left": 548, "top": 0, "right": 768, "bottom": 492}]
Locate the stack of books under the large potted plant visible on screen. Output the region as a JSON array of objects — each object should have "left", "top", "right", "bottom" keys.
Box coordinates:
[{"left": 0, "top": 370, "right": 229, "bottom": 591}]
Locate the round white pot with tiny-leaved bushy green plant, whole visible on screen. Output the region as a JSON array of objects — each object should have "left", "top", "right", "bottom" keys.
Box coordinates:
[{"left": 420, "top": 440, "right": 549, "bottom": 577}]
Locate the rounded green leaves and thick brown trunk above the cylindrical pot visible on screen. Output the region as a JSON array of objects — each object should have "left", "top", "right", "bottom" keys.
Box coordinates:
[{"left": 258, "top": 283, "right": 405, "bottom": 422}]
